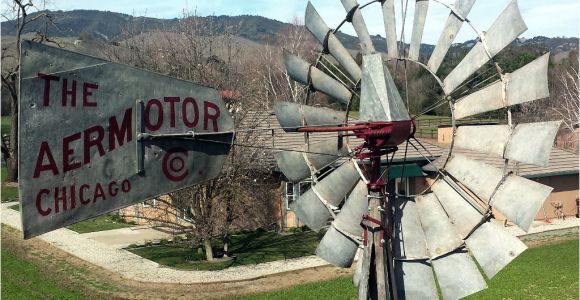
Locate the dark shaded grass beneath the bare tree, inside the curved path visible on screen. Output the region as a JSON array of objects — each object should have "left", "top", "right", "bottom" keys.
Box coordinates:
[{"left": 129, "top": 231, "right": 323, "bottom": 270}]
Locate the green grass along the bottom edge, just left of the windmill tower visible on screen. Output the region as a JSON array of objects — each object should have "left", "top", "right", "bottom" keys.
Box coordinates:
[{"left": 234, "top": 276, "right": 358, "bottom": 300}]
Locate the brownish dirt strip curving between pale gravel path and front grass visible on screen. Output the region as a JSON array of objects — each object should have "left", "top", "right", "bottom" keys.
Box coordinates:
[{"left": 2, "top": 225, "right": 353, "bottom": 299}]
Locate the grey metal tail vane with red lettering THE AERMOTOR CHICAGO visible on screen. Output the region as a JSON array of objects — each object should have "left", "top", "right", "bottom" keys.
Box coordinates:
[{"left": 19, "top": 41, "right": 234, "bottom": 238}]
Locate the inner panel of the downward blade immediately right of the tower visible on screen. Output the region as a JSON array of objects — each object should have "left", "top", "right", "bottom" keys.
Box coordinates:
[{"left": 393, "top": 198, "right": 429, "bottom": 260}]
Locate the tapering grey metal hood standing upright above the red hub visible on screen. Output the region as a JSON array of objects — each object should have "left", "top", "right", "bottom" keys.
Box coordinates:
[{"left": 359, "top": 54, "right": 410, "bottom": 122}]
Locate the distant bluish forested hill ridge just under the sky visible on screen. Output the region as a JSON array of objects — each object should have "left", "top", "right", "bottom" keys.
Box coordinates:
[{"left": 2, "top": 10, "right": 578, "bottom": 54}]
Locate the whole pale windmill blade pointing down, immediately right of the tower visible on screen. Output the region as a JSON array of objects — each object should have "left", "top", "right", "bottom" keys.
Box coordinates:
[{"left": 393, "top": 198, "right": 437, "bottom": 299}]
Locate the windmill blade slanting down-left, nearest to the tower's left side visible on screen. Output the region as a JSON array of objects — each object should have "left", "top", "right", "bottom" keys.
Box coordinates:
[{"left": 316, "top": 180, "right": 368, "bottom": 268}]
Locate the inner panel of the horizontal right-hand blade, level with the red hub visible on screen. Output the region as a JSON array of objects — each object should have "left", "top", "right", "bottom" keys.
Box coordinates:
[{"left": 453, "top": 125, "right": 510, "bottom": 157}]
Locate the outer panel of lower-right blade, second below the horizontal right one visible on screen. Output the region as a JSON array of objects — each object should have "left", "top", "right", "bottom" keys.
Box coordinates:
[{"left": 465, "top": 221, "right": 527, "bottom": 278}]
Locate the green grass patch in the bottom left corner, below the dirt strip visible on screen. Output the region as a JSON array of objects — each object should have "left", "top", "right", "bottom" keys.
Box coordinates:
[{"left": 1, "top": 247, "right": 85, "bottom": 299}]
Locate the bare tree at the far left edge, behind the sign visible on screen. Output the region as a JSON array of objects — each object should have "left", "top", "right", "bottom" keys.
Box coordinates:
[{"left": 1, "top": 0, "right": 50, "bottom": 182}]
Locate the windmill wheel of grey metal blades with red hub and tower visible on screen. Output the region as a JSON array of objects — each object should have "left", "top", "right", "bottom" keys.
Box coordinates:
[{"left": 274, "top": 0, "right": 560, "bottom": 299}]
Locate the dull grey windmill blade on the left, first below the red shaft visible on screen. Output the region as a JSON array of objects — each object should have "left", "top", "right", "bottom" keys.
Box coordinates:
[{"left": 274, "top": 139, "right": 349, "bottom": 182}]
